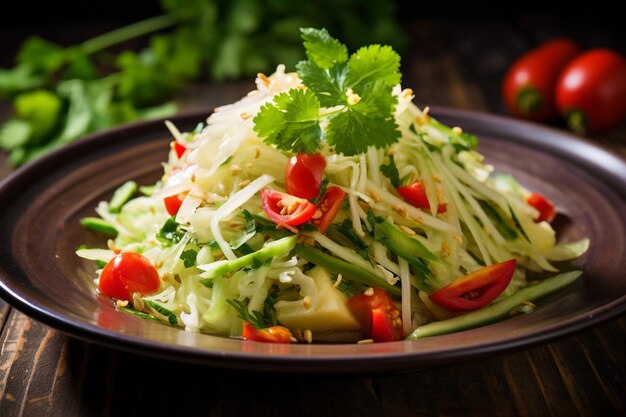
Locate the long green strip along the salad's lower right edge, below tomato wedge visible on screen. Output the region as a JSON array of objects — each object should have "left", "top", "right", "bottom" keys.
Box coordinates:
[{"left": 406, "top": 271, "right": 582, "bottom": 340}]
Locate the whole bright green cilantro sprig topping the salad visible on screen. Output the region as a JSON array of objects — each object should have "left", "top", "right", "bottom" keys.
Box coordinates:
[{"left": 254, "top": 28, "right": 402, "bottom": 155}]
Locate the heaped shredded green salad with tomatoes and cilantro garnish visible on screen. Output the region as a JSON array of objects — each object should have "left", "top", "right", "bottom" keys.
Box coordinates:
[{"left": 77, "top": 29, "right": 589, "bottom": 343}]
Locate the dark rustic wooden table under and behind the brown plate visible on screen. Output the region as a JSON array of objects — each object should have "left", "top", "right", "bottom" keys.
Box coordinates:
[{"left": 0, "top": 16, "right": 626, "bottom": 417}]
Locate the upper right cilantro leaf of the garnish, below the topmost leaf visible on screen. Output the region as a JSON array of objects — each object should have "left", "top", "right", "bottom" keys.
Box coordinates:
[{"left": 346, "top": 45, "right": 402, "bottom": 94}]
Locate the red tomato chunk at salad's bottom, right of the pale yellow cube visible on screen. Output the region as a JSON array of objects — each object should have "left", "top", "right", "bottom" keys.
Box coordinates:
[{"left": 348, "top": 288, "right": 404, "bottom": 342}]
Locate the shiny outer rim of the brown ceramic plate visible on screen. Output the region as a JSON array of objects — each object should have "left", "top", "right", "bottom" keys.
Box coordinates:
[{"left": 0, "top": 106, "right": 626, "bottom": 374}]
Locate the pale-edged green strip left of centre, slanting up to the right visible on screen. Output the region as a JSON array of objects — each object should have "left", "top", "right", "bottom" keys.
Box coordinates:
[{"left": 198, "top": 235, "right": 297, "bottom": 282}]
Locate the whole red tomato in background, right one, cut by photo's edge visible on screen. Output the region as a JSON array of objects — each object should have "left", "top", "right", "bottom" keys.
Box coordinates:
[{"left": 556, "top": 48, "right": 626, "bottom": 133}]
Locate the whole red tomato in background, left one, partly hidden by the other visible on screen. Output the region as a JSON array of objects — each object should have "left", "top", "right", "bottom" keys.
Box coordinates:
[{"left": 502, "top": 38, "right": 581, "bottom": 121}]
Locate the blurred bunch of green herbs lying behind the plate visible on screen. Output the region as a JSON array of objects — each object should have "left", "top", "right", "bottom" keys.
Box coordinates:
[{"left": 0, "top": 0, "right": 406, "bottom": 166}]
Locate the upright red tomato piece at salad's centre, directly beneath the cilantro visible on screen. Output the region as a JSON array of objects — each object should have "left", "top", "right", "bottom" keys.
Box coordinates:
[{"left": 285, "top": 153, "right": 326, "bottom": 199}]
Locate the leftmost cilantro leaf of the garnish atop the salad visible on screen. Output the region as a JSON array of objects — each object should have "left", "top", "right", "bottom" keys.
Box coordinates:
[{"left": 254, "top": 89, "right": 322, "bottom": 153}]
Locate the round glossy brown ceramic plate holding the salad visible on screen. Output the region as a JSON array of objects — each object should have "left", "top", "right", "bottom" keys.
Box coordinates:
[{"left": 0, "top": 108, "right": 626, "bottom": 373}]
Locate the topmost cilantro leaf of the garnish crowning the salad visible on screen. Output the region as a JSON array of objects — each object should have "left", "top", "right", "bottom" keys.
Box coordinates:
[{"left": 300, "top": 28, "right": 348, "bottom": 69}]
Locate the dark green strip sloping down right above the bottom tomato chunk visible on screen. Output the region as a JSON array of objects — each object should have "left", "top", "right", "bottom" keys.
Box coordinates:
[{"left": 296, "top": 245, "right": 402, "bottom": 296}]
